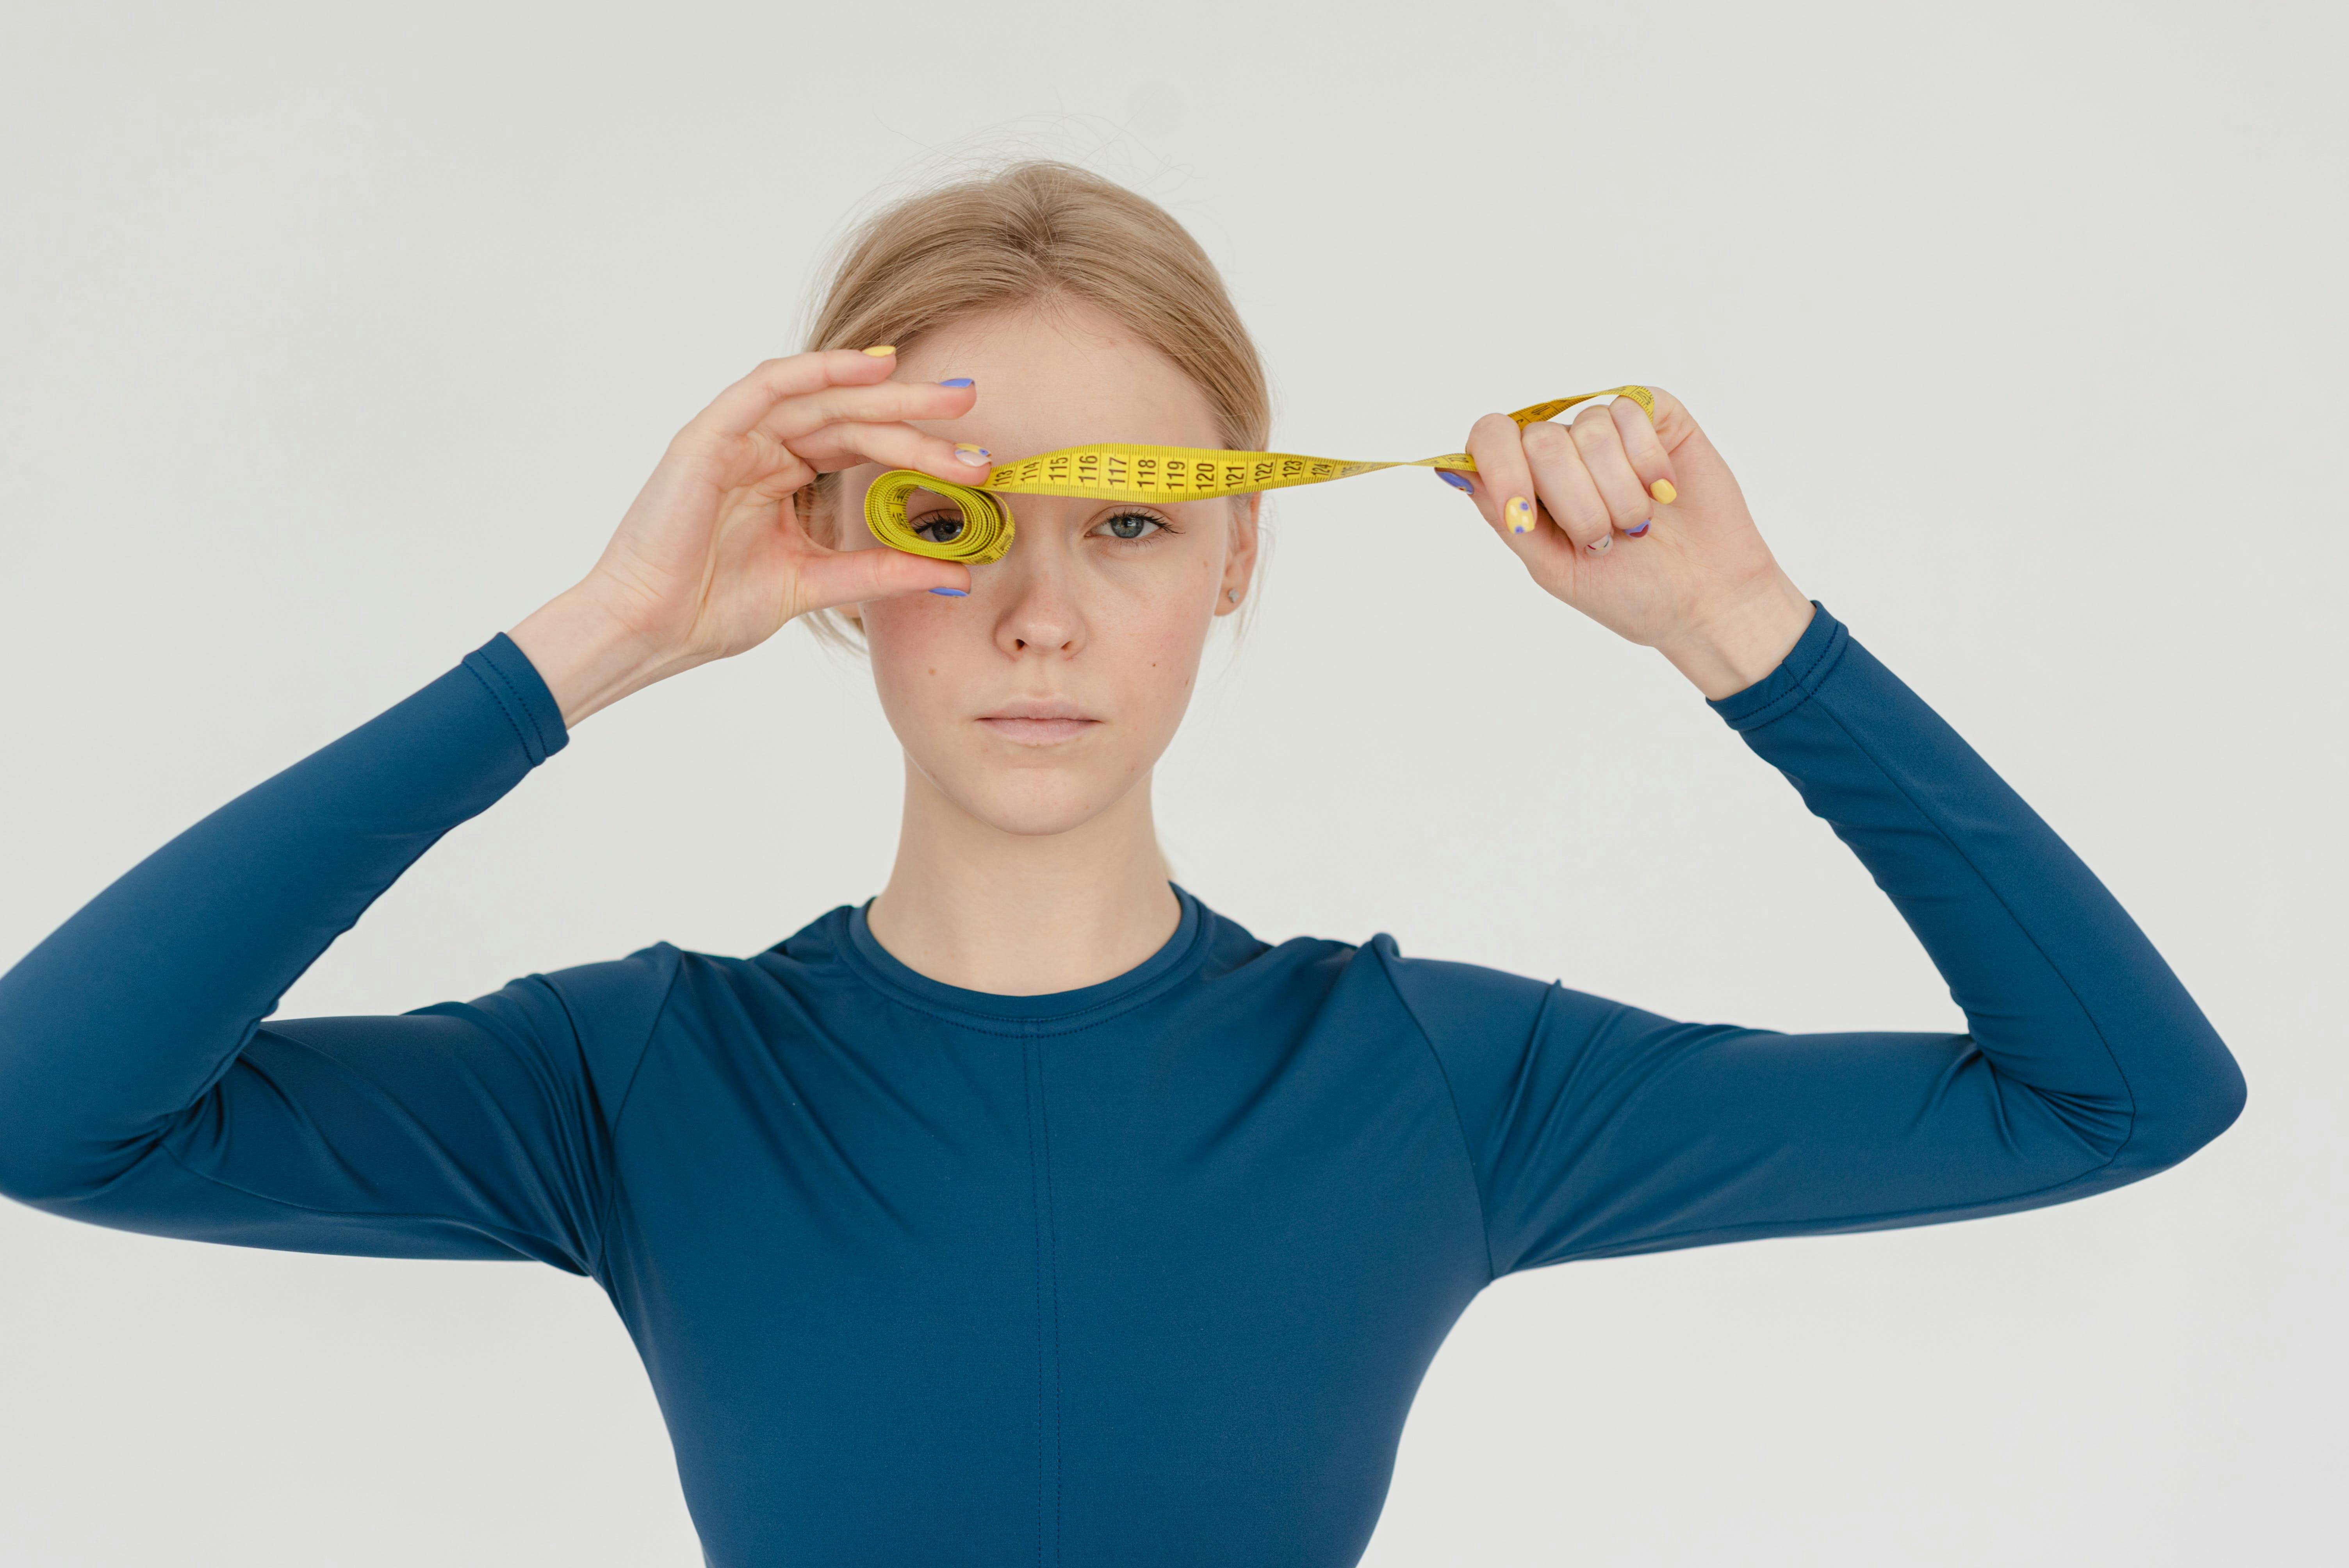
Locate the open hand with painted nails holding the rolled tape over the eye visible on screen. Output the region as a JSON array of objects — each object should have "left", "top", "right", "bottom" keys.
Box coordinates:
[{"left": 507, "top": 350, "right": 987, "bottom": 725}]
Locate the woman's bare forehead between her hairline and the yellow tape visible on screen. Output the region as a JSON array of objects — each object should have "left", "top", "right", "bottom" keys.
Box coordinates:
[{"left": 897, "top": 305, "right": 1224, "bottom": 462}]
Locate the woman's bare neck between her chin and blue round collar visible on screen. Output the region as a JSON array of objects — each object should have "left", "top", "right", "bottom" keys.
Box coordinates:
[{"left": 864, "top": 761, "right": 1182, "bottom": 995}]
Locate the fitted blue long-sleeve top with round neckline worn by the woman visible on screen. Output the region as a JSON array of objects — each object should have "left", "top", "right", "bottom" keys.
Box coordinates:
[{"left": 0, "top": 608, "right": 2243, "bottom": 1568}]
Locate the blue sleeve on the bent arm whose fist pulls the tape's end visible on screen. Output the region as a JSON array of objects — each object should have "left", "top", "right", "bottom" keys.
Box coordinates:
[{"left": 1381, "top": 608, "right": 2243, "bottom": 1275}]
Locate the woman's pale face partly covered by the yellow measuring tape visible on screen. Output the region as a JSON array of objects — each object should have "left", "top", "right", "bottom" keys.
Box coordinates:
[{"left": 834, "top": 308, "right": 1257, "bottom": 833}]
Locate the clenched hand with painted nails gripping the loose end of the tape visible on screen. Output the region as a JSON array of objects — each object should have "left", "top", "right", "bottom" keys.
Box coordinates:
[{"left": 1468, "top": 387, "right": 1811, "bottom": 697}]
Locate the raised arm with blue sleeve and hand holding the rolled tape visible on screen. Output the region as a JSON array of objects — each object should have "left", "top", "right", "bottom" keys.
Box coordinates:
[{"left": 0, "top": 352, "right": 1000, "bottom": 1272}]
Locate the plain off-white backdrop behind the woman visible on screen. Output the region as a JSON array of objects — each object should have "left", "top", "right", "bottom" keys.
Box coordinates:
[{"left": 0, "top": 0, "right": 2349, "bottom": 1568}]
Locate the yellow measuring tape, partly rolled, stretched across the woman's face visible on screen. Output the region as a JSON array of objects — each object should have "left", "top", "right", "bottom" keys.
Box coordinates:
[{"left": 864, "top": 387, "right": 1656, "bottom": 563}]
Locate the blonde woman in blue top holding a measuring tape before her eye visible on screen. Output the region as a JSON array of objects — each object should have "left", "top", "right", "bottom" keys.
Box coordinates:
[{"left": 0, "top": 164, "right": 2243, "bottom": 1568}]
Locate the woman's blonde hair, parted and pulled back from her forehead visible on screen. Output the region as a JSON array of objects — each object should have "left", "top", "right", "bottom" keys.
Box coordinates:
[{"left": 798, "top": 160, "right": 1273, "bottom": 648}]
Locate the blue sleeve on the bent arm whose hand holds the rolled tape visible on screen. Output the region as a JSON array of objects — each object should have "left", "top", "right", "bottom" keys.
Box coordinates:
[{"left": 0, "top": 634, "right": 677, "bottom": 1272}]
